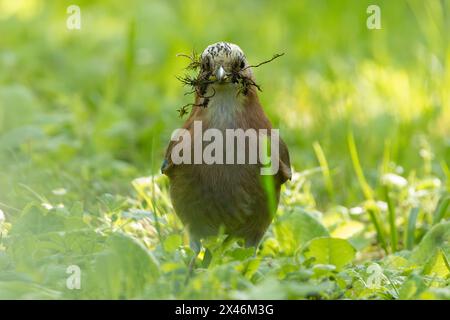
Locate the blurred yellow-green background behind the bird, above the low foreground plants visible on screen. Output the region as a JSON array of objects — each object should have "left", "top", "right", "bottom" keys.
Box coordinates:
[{"left": 0, "top": 0, "right": 450, "bottom": 296}]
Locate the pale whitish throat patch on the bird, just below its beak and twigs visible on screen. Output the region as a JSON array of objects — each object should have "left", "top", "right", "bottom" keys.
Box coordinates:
[{"left": 206, "top": 84, "right": 244, "bottom": 129}]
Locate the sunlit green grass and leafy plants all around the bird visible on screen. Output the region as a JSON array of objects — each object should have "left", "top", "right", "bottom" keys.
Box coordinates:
[{"left": 0, "top": 0, "right": 450, "bottom": 299}]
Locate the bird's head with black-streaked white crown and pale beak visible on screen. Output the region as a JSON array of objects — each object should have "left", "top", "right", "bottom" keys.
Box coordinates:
[{"left": 200, "top": 42, "right": 253, "bottom": 89}]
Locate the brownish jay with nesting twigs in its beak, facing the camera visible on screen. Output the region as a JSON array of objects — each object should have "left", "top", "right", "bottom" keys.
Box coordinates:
[{"left": 161, "top": 42, "right": 292, "bottom": 252}]
